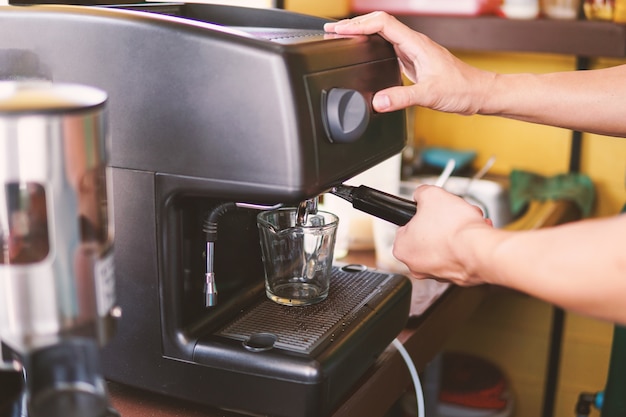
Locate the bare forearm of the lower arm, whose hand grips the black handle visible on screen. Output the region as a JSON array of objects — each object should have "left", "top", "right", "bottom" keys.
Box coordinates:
[{"left": 470, "top": 215, "right": 626, "bottom": 324}]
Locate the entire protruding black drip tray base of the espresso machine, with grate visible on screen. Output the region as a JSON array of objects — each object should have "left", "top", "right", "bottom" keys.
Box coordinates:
[{"left": 193, "top": 265, "right": 412, "bottom": 417}]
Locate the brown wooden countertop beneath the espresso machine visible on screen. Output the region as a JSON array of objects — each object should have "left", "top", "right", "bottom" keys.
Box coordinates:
[{"left": 108, "top": 251, "right": 490, "bottom": 417}]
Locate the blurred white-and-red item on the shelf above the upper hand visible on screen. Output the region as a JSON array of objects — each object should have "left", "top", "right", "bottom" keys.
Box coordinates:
[{"left": 351, "top": 0, "right": 502, "bottom": 16}]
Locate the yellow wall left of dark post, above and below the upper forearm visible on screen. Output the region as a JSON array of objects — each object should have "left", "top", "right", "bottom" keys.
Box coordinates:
[{"left": 415, "top": 54, "right": 575, "bottom": 175}]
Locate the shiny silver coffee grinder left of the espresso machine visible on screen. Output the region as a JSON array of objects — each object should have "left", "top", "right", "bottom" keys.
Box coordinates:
[{"left": 0, "top": 81, "right": 116, "bottom": 417}]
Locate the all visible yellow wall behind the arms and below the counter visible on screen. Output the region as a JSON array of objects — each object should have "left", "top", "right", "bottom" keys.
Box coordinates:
[{"left": 415, "top": 53, "right": 626, "bottom": 417}]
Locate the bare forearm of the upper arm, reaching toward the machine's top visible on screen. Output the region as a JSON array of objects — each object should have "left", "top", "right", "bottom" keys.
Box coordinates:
[{"left": 478, "top": 66, "right": 626, "bottom": 136}]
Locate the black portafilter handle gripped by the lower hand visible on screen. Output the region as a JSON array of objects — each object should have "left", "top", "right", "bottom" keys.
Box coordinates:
[{"left": 330, "top": 184, "right": 417, "bottom": 226}]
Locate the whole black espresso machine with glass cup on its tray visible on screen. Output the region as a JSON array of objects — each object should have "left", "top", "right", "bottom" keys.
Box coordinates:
[{"left": 0, "top": 3, "right": 411, "bottom": 417}]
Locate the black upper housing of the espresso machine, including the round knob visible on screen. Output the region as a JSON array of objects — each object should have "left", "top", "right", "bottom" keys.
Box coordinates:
[{"left": 0, "top": 3, "right": 406, "bottom": 203}]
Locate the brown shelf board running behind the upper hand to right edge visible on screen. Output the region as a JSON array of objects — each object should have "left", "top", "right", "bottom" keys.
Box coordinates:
[{"left": 396, "top": 15, "right": 626, "bottom": 58}]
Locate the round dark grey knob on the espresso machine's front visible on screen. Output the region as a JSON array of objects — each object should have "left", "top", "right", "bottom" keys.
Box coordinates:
[{"left": 322, "top": 88, "right": 370, "bottom": 143}]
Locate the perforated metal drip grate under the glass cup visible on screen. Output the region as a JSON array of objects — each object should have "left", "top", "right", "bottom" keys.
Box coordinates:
[{"left": 218, "top": 265, "right": 394, "bottom": 354}]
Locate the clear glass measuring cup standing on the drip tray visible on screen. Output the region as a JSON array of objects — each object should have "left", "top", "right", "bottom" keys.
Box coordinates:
[{"left": 257, "top": 208, "right": 339, "bottom": 306}]
